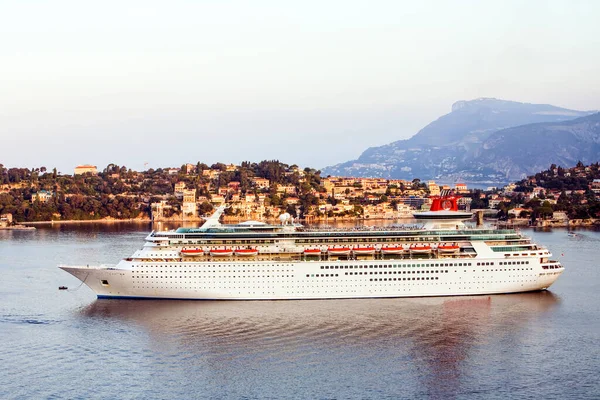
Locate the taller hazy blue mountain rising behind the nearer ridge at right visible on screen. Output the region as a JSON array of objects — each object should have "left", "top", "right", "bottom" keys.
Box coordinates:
[{"left": 323, "top": 98, "right": 598, "bottom": 182}]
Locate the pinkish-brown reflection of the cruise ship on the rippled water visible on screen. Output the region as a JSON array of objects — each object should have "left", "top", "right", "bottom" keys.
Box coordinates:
[{"left": 82, "top": 291, "right": 560, "bottom": 394}]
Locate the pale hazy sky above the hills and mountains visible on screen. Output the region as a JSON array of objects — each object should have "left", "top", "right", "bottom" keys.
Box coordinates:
[{"left": 0, "top": 0, "right": 600, "bottom": 173}]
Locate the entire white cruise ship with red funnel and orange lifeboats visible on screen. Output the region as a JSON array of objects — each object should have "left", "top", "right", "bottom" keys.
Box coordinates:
[{"left": 60, "top": 196, "right": 564, "bottom": 300}]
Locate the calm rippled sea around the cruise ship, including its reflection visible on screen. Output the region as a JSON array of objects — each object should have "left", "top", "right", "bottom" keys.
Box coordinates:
[{"left": 0, "top": 224, "right": 600, "bottom": 399}]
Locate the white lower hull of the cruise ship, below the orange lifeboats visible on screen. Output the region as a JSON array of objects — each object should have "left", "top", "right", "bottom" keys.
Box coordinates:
[{"left": 61, "top": 258, "right": 564, "bottom": 300}]
